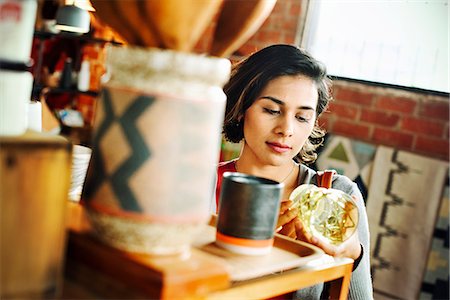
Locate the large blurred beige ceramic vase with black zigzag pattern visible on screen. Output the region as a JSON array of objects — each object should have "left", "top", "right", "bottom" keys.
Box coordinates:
[{"left": 82, "top": 46, "right": 230, "bottom": 255}]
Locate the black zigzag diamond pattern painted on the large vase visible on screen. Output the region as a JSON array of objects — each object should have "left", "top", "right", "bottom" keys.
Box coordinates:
[{"left": 85, "top": 88, "right": 155, "bottom": 212}]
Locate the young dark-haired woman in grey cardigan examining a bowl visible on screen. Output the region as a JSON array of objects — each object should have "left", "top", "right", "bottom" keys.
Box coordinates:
[{"left": 216, "top": 45, "right": 373, "bottom": 300}]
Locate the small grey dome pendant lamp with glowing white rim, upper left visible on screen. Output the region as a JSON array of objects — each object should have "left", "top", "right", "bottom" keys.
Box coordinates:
[{"left": 55, "top": 5, "right": 91, "bottom": 33}]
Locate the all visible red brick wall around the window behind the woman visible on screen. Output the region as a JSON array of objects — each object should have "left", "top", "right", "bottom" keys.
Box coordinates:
[{"left": 202, "top": 0, "right": 449, "bottom": 161}]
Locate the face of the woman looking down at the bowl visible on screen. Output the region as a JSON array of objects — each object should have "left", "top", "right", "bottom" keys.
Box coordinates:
[{"left": 242, "top": 75, "right": 318, "bottom": 166}]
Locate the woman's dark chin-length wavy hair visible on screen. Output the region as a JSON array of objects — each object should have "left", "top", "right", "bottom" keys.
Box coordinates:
[{"left": 223, "top": 45, "right": 331, "bottom": 163}]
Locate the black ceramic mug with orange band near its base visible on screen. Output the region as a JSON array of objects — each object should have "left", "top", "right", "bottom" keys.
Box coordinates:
[{"left": 216, "top": 172, "right": 284, "bottom": 255}]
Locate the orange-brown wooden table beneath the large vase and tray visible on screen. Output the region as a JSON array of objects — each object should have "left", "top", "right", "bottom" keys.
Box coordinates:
[{"left": 61, "top": 203, "right": 353, "bottom": 299}]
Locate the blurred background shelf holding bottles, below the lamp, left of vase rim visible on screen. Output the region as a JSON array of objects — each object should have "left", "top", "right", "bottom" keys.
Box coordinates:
[{"left": 32, "top": 31, "right": 121, "bottom": 98}]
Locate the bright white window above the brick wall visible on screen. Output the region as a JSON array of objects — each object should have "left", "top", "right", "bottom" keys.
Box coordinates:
[{"left": 301, "top": 0, "right": 449, "bottom": 93}]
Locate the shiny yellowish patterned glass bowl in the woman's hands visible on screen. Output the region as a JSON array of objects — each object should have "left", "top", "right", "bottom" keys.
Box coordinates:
[{"left": 289, "top": 184, "right": 359, "bottom": 245}]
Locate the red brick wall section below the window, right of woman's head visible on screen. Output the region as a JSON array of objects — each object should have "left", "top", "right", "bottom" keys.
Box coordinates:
[{"left": 322, "top": 80, "right": 449, "bottom": 161}]
